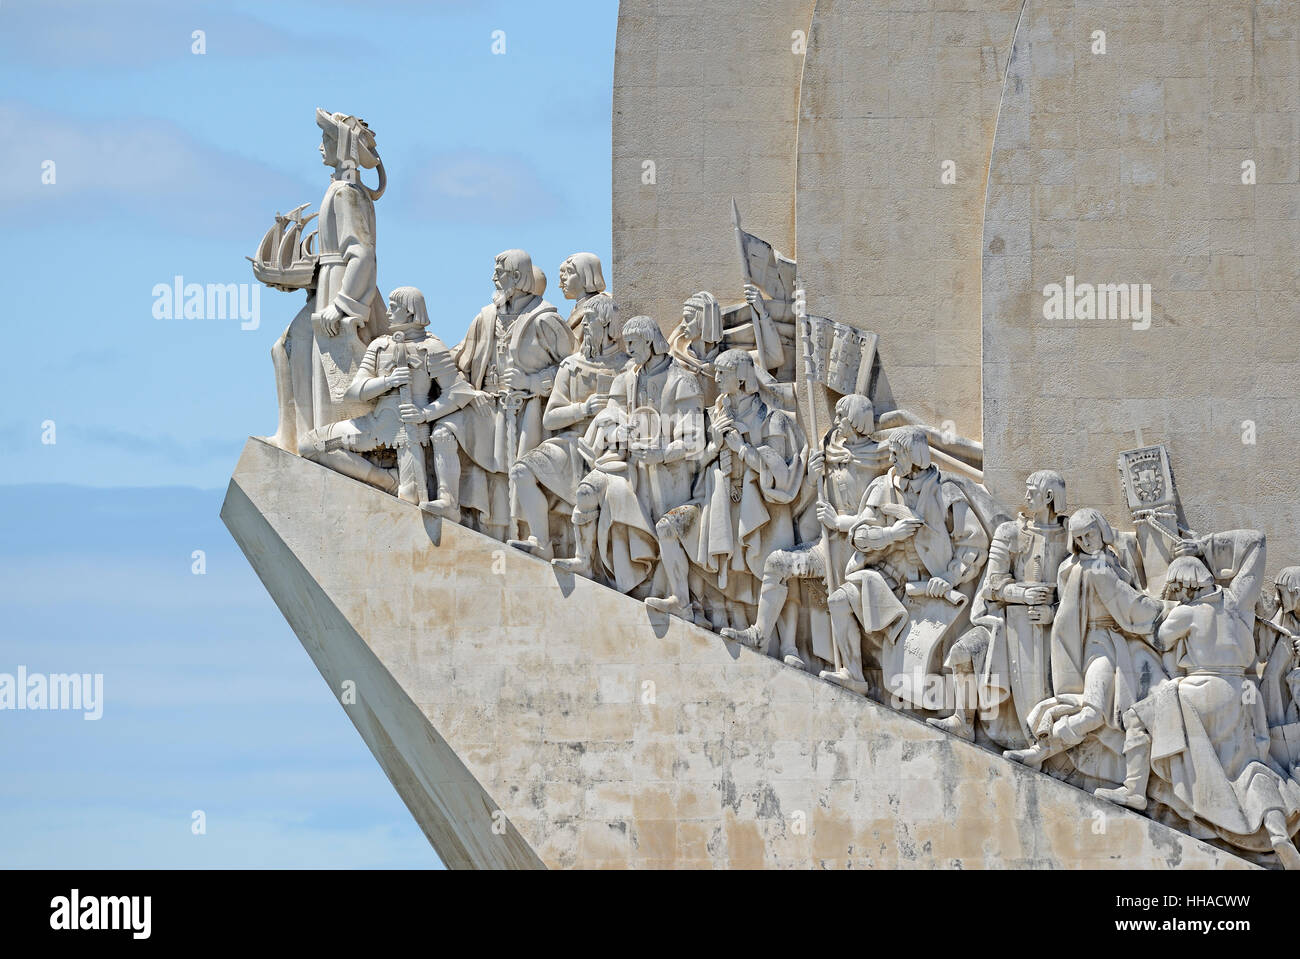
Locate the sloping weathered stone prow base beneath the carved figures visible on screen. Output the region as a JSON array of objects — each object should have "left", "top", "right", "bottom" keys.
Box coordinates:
[{"left": 222, "top": 439, "right": 1248, "bottom": 868}]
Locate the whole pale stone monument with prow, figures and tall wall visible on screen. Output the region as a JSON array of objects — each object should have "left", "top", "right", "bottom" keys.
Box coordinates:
[{"left": 222, "top": 0, "right": 1300, "bottom": 868}]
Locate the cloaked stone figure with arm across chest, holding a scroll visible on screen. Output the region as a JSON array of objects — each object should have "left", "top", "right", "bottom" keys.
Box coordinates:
[{"left": 822, "top": 426, "right": 988, "bottom": 704}]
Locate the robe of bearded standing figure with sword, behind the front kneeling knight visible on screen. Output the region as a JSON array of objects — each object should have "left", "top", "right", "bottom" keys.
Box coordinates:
[{"left": 439, "top": 294, "right": 573, "bottom": 526}]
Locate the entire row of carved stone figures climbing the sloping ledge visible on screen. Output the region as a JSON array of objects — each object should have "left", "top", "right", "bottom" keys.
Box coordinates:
[{"left": 255, "top": 110, "right": 1300, "bottom": 868}]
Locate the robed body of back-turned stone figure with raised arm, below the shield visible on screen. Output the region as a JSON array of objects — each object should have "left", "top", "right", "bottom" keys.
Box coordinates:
[{"left": 1134, "top": 530, "right": 1300, "bottom": 851}]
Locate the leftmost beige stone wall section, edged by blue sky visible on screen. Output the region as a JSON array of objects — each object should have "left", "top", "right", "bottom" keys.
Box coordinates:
[{"left": 612, "top": 0, "right": 814, "bottom": 330}]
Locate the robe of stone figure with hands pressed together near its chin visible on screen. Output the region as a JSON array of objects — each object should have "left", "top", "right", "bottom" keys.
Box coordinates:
[{"left": 681, "top": 394, "right": 807, "bottom": 606}]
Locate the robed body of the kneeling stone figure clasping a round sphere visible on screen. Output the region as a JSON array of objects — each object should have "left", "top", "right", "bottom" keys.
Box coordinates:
[{"left": 588, "top": 355, "right": 705, "bottom": 593}]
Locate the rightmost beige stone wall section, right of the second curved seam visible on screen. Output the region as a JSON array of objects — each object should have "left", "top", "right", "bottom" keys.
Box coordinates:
[{"left": 977, "top": 0, "right": 1300, "bottom": 553}]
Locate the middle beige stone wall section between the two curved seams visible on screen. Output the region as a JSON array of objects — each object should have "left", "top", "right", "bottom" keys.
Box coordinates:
[{"left": 796, "top": 0, "right": 1019, "bottom": 439}]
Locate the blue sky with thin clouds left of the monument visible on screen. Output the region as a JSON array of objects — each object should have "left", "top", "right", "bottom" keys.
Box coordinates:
[{"left": 0, "top": 0, "right": 618, "bottom": 867}]
